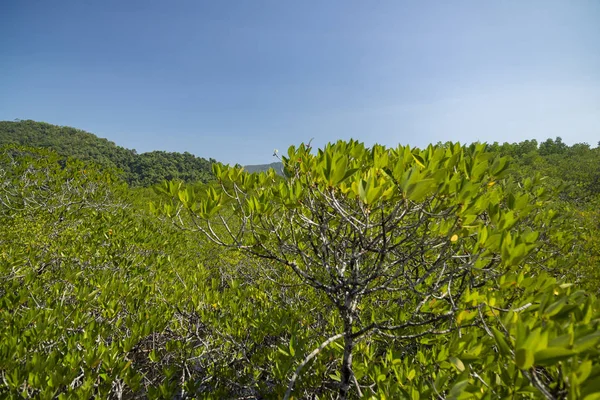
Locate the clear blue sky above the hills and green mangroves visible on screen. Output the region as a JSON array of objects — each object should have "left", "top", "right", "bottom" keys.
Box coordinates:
[{"left": 0, "top": 0, "right": 600, "bottom": 164}]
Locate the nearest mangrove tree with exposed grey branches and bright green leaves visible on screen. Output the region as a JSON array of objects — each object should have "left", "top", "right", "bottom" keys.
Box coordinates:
[{"left": 164, "top": 142, "right": 596, "bottom": 399}]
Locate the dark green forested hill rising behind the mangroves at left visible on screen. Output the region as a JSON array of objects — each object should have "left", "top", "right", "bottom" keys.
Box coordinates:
[{"left": 0, "top": 120, "right": 214, "bottom": 186}]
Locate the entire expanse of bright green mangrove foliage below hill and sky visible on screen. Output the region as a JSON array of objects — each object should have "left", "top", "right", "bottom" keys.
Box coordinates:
[{"left": 0, "top": 133, "right": 600, "bottom": 400}]
